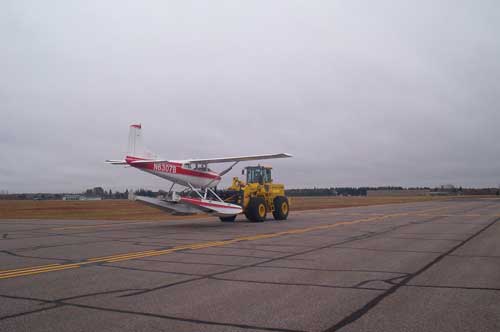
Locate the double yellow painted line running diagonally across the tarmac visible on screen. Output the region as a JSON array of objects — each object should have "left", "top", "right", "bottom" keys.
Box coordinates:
[{"left": 0, "top": 208, "right": 445, "bottom": 279}]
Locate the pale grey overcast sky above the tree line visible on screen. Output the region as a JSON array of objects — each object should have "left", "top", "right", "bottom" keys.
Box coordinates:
[{"left": 0, "top": 0, "right": 500, "bottom": 192}]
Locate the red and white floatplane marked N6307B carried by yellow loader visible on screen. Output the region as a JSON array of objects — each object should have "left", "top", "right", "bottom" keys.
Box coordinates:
[{"left": 106, "top": 124, "right": 291, "bottom": 217}]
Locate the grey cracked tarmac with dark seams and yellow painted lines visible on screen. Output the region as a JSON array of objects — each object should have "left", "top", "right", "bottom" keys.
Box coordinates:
[{"left": 0, "top": 199, "right": 500, "bottom": 332}]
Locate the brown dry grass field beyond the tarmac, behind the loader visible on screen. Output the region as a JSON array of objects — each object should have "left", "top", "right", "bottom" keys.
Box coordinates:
[{"left": 0, "top": 196, "right": 466, "bottom": 220}]
